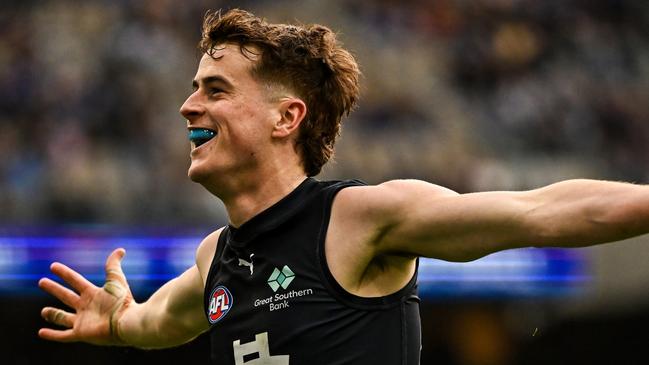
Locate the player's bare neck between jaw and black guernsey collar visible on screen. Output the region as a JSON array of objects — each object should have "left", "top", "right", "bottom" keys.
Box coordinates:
[{"left": 205, "top": 169, "right": 306, "bottom": 227}]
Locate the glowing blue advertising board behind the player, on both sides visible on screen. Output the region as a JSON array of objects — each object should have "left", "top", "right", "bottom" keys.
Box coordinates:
[{"left": 0, "top": 226, "right": 589, "bottom": 299}]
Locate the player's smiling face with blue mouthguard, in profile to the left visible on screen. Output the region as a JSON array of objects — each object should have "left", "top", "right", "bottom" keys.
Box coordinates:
[{"left": 180, "top": 44, "right": 279, "bottom": 184}]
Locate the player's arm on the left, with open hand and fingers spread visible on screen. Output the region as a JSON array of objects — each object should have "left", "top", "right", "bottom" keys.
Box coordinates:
[{"left": 39, "top": 249, "right": 207, "bottom": 348}]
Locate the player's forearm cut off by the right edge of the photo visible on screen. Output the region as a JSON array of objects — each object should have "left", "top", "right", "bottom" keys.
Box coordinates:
[{"left": 528, "top": 180, "right": 649, "bottom": 247}]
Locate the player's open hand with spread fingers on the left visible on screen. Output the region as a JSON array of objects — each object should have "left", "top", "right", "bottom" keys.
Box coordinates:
[{"left": 38, "top": 248, "right": 135, "bottom": 345}]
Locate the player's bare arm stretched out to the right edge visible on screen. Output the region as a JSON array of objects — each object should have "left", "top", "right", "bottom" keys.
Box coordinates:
[{"left": 340, "top": 180, "right": 649, "bottom": 261}]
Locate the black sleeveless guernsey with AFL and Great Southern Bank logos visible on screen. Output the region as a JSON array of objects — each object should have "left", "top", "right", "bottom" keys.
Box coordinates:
[{"left": 204, "top": 178, "right": 421, "bottom": 365}]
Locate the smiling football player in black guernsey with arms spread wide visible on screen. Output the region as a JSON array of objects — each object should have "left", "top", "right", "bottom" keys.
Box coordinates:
[{"left": 39, "top": 10, "right": 649, "bottom": 365}]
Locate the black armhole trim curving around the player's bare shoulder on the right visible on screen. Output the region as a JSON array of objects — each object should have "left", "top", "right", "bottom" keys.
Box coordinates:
[{"left": 316, "top": 180, "right": 419, "bottom": 310}]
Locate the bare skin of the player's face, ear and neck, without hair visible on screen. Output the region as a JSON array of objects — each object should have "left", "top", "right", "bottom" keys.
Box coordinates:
[{"left": 180, "top": 45, "right": 306, "bottom": 226}]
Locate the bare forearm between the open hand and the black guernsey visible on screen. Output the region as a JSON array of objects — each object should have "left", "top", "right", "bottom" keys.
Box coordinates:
[{"left": 117, "top": 270, "right": 207, "bottom": 349}]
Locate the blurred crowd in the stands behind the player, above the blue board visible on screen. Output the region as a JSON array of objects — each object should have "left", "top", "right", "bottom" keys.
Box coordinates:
[{"left": 0, "top": 0, "right": 649, "bottom": 225}]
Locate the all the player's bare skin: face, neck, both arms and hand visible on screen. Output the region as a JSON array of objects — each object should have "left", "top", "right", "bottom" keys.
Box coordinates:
[{"left": 39, "top": 44, "right": 649, "bottom": 348}]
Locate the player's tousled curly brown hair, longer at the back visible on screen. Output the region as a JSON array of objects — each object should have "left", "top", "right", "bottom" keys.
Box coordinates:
[{"left": 198, "top": 9, "right": 360, "bottom": 176}]
